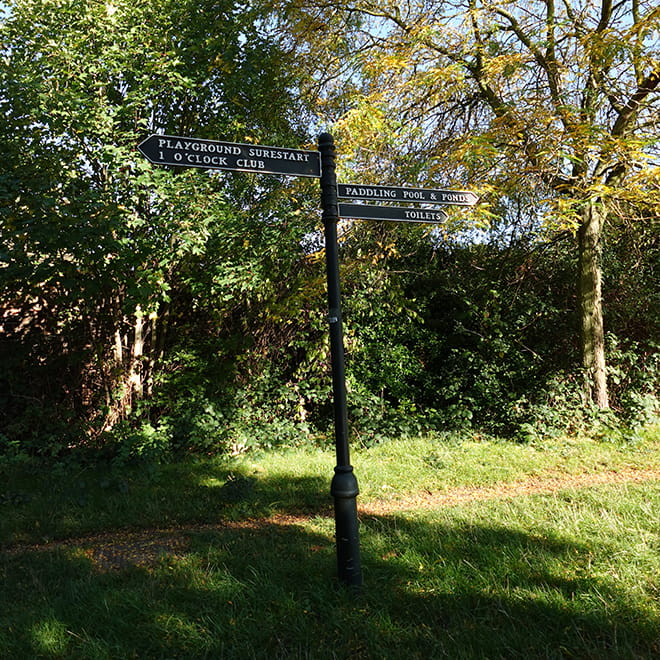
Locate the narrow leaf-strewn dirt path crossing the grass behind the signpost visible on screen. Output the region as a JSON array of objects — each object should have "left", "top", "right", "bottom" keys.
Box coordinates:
[{"left": 2, "top": 468, "right": 660, "bottom": 571}]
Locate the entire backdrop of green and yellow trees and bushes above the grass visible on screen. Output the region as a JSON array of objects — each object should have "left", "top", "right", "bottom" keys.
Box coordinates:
[{"left": 0, "top": 0, "right": 660, "bottom": 456}]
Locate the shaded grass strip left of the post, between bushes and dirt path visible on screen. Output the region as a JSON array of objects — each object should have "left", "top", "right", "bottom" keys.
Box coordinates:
[{"left": 0, "top": 461, "right": 332, "bottom": 551}]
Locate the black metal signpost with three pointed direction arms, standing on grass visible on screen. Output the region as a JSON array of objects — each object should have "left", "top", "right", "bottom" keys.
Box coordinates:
[{"left": 138, "top": 133, "right": 477, "bottom": 589}]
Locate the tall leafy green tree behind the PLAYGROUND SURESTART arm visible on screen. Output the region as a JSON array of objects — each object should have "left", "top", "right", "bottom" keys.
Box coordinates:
[{"left": 0, "top": 0, "right": 314, "bottom": 451}]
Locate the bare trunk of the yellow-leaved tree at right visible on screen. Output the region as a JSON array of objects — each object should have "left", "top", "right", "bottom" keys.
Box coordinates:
[{"left": 578, "top": 200, "right": 609, "bottom": 408}]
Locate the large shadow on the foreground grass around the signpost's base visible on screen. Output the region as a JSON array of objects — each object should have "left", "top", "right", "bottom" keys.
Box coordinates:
[{"left": 0, "top": 475, "right": 660, "bottom": 659}]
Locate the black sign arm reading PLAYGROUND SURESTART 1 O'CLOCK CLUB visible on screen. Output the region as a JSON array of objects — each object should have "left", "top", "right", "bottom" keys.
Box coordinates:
[{"left": 138, "top": 135, "right": 321, "bottom": 178}]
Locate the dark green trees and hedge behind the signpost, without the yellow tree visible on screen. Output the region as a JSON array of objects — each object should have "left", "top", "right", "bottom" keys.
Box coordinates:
[{"left": 0, "top": 0, "right": 660, "bottom": 458}]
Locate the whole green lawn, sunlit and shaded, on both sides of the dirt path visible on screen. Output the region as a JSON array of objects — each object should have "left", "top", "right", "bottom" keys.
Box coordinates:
[{"left": 0, "top": 427, "right": 660, "bottom": 659}]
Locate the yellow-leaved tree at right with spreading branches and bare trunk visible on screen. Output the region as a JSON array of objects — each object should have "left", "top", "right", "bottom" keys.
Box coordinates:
[{"left": 278, "top": 0, "right": 660, "bottom": 408}]
